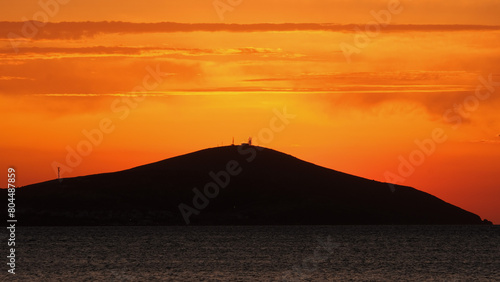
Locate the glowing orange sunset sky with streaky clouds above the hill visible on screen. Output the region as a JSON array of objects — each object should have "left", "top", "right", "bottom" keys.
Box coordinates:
[{"left": 0, "top": 0, "right": 500, "bottom": 223}]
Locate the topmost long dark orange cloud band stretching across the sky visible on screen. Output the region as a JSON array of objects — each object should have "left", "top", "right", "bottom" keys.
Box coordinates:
[{"left": 0, "top": 21, "right": 500, "bottom": 40}]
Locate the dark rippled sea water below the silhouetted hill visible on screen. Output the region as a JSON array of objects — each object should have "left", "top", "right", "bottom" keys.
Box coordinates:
[{"left": 0, "top": 226, "right": 500, "bottom": 281}]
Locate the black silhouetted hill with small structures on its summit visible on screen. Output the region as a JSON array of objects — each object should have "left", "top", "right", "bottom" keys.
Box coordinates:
[{"left": 3, "top": 143, "right": 489, "bottom": 226}]
